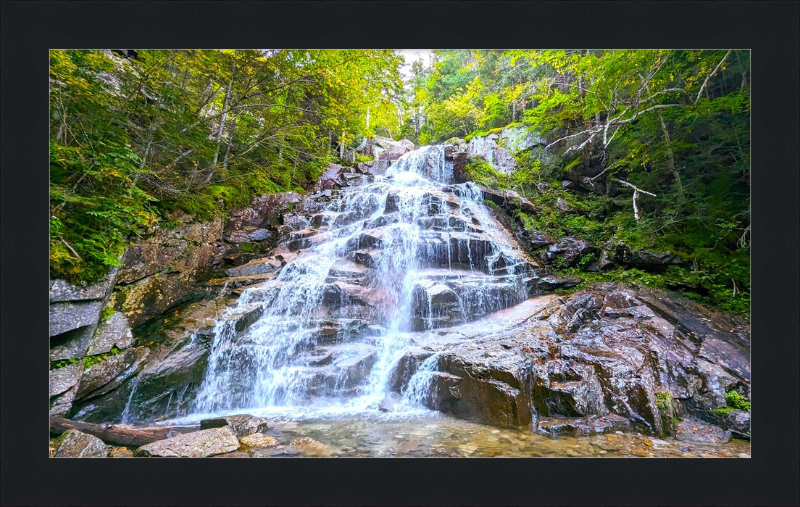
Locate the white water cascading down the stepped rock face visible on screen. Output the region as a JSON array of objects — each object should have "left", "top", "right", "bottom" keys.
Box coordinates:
[{"left": 189, "top": 146, "right": 531, "bottom": 417}]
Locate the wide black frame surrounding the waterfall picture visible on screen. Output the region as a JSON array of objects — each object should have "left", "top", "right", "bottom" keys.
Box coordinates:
[{"left": 0, "top": 1, "right": 800, "bottom": 506}]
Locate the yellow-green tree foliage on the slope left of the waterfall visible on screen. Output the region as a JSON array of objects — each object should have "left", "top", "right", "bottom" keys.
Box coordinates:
[{"left": 50, "top": 50, "right": 402, "bottom": 282}]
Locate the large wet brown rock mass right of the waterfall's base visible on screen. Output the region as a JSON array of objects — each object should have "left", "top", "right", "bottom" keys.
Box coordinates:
[{"left": 394, "top": 288, "right": 749, "bottom": 435}]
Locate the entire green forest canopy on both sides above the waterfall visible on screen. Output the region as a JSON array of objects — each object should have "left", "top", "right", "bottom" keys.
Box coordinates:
[{"left": 50, "top": 50, "right": 750, "bottom": 311}]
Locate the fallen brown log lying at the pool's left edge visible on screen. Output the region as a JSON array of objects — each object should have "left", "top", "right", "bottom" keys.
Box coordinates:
[{"left": 50, "top": 417, "right": 190, "bottom": 447}]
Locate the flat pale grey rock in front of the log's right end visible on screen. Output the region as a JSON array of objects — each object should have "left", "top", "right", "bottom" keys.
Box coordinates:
[{"left": 135, "top": 426, "right": 239, "bottom": 458}]
